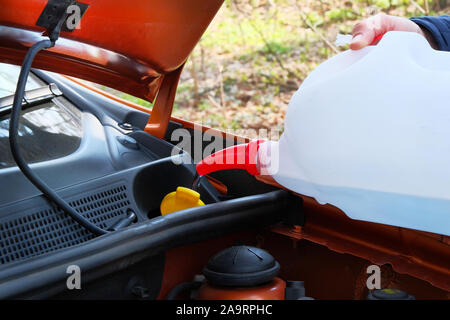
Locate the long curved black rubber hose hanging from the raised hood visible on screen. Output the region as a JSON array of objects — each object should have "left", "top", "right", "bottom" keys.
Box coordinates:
[{"left": 9, "top": 40, "right": 107, "bottom": 235}]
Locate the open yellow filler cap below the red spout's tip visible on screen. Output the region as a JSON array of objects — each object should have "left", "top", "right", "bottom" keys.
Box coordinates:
[{"left": 160, "top": 187, "right": 205, "bottom": 215}]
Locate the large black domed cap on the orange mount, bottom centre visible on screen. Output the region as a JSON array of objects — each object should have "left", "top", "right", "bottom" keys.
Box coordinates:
[{"left": 203, "top": 246, "right": 280, "bottom": 287}]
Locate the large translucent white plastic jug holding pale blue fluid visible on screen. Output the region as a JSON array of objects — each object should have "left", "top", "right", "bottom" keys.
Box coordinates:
[{"left": 258, "top": 32, "right": 450, "bottom": 235}]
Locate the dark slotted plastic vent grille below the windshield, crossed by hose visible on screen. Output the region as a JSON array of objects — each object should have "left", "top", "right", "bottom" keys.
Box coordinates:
[{"left": 0, "top": 184, "right": 130, "bottom": 265}]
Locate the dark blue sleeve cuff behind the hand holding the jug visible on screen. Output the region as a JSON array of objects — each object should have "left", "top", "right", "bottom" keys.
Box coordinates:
[{"left": 411, "top": 15, "right": 450, "bottom": 51}]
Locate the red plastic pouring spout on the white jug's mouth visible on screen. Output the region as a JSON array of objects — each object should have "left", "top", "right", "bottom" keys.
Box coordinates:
[{"left": 196, "top": 140, "right": 264, "bottom": 176}]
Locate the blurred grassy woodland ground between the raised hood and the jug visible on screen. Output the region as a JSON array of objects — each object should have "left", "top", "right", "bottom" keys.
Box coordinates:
[{"left": 114, "top": 0, "right": 450, "bottom": 135}]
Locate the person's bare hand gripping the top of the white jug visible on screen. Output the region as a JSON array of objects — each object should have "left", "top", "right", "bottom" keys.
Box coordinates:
[{"left": 350, "top": 13, "right": 436, "bottom": 50}]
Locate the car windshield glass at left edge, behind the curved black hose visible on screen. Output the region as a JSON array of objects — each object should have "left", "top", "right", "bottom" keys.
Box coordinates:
[{"left": 0, "top": 63, "right": 83, "bottom": 169}]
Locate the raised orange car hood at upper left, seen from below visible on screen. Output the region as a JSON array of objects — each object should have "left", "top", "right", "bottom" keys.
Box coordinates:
[{"left": 0, "top": 0, "right": 223, "bottom": 101}]
